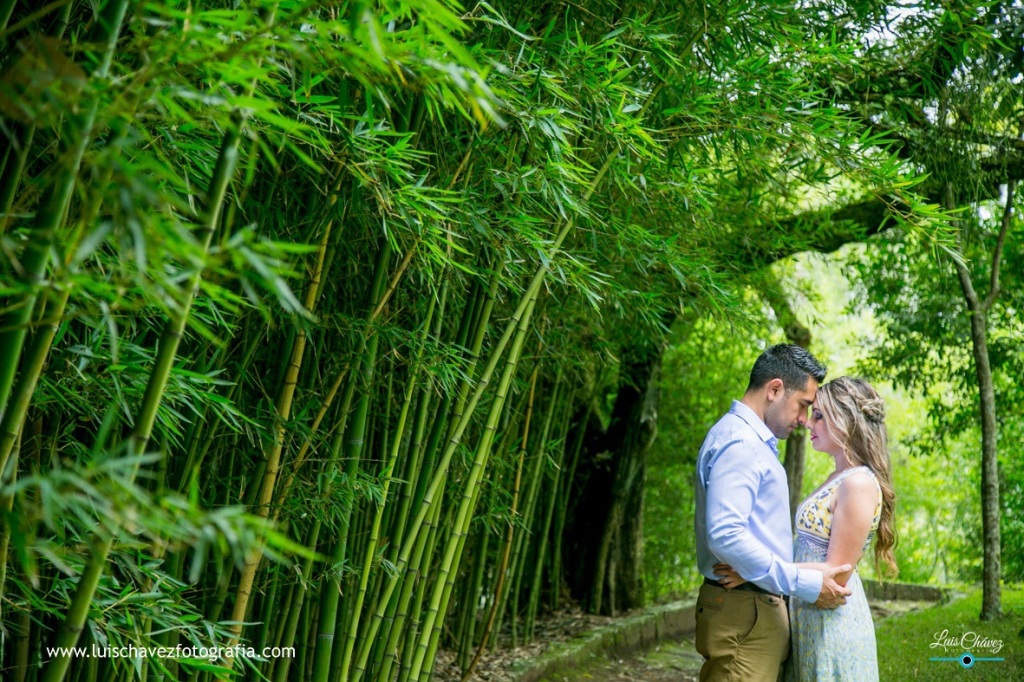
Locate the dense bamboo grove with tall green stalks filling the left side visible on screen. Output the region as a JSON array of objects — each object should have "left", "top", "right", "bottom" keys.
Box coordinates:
[{"left": 0, "top": 0, "right": 942, "bottom": 682}]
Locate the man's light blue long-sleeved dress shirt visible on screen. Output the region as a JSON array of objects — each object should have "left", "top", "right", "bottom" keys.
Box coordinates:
[{"left": 693, "top": 400, "right": 822, "bottom": 602}]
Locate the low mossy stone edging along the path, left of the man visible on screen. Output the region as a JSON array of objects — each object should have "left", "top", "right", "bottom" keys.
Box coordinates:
[{"left": 512, "top": 601, "right": 696, "bottom": 682}]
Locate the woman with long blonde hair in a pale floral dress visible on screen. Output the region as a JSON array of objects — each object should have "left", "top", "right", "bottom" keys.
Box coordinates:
[{"left": 716, "top": 377, "right": 897, "bottom": 682}]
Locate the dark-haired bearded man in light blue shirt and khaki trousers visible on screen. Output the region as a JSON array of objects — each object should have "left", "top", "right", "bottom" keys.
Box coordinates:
[{"left": 694, "top": 344, "right": 852, "bottom": 682}]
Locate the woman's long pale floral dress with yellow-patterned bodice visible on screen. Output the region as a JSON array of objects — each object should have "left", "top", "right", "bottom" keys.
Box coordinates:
[{"left": 785, "top": 467, "right": 882, "bottom": 682}]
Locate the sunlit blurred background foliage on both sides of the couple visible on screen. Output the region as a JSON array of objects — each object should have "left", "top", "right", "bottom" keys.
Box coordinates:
[{"left": 645, "top": 237, "right": 1020, "bottom": 600}]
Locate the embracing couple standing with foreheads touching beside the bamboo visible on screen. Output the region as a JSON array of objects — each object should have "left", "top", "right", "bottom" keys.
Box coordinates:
[{"left": 694, "top": 344, "right": 896, "bottom": 682}]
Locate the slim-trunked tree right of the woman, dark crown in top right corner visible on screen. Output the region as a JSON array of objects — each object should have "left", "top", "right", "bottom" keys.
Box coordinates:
[{"left": 831, "top": 2, "right": 1024, "bottom": 620}]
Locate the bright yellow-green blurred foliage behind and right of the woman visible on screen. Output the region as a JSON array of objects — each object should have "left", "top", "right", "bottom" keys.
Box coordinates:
[{"left": 773, "top": 254, "right": 981, "bottom": 584}]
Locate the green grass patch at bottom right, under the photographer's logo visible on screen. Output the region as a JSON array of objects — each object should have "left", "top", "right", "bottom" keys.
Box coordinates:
[{"left": 876, "top": 585, "right": 1024, "bottom": 681}]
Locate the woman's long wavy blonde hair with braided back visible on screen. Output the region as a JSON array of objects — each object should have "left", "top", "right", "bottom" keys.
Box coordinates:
[{"left": 817, "top": 377, "right": 899, "bottom": 576}]
